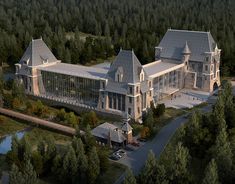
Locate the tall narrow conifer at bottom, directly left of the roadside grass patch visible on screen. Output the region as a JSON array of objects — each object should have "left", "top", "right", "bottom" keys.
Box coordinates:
[{"left": 87, "top": 147, "right": 100, "bottom": 184}]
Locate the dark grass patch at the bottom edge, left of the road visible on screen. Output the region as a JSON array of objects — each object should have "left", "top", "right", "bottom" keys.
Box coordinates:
[{"left": 97, "top": 162, "right": 127, "bottom": 184}]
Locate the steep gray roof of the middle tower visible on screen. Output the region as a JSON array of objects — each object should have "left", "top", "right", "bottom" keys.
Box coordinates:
[{"left": 108, "top": 50, "right": 147, "bottom": 83}]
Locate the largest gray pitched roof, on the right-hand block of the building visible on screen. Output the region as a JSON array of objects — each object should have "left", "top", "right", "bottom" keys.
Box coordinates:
[{"left": 159, "top": 29, "right": 216, "bottom": 61}]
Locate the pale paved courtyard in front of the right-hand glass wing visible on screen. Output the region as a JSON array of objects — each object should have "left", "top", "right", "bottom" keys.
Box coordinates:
[{"left": 159, "top": 89, "right": 210, "bottom": 109}]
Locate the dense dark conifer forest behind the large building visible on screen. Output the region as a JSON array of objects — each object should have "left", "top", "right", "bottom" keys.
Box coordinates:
[{"left": 0, "top": 0, "right": 235, "bottom": 75}]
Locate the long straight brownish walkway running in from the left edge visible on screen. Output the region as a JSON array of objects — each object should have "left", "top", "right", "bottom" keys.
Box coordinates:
[{"left": 0, "top": 108, "right": 84, "bottom": 135}]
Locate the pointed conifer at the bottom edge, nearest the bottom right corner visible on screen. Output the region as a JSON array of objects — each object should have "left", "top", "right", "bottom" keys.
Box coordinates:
[{"left": 202, "top": 159, "right": 220, "bottom": 184}]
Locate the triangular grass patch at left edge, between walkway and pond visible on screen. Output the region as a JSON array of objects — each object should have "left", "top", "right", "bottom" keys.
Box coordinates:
[{"left": 0, "top": 115, "right": 27, "bottom": 137}]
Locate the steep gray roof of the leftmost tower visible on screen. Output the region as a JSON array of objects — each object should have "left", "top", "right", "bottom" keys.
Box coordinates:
[{"left": 20, "top": 39, "right": 57, "bottom": 66}]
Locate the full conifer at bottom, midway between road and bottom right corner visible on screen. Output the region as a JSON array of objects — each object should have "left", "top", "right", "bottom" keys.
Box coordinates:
[{"left": 171, "top": 142, "right": 190, "bottom": 184}]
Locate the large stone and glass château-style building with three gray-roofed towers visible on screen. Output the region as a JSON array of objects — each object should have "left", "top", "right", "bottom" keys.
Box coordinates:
[{"left": 16, "top": 29, "right": 221, "bottom": 120}]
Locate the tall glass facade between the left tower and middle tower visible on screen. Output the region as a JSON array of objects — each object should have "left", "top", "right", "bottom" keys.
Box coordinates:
[{"left": 40, "top": 71, "right": 100, "bottom": 107}]
